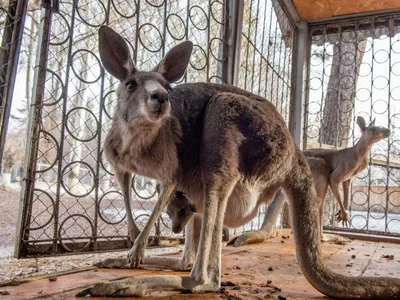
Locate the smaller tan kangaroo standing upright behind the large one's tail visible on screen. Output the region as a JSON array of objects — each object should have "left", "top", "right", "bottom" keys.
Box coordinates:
[{"left": 230, "top": 116, "right": 390, "bottom": 246}]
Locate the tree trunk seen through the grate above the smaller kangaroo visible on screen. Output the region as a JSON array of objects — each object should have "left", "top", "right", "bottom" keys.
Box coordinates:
[{"left": 319, "top": 38, "right": 366, "bottom": 147}]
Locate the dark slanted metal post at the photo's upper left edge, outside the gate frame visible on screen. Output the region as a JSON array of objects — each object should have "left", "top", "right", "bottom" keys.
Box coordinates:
[{"left": 0, "top": 0, "right": 28, "bottom": 174}]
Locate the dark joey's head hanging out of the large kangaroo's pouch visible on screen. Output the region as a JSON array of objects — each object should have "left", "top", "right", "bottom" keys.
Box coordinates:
[{"left": 167, "top": 192, "right": 196, "bottom": 233}]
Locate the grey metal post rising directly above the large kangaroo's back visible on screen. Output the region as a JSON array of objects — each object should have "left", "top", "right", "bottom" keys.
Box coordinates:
[{"left": 222, "top": 0, "right": 244, "bottom": 85}]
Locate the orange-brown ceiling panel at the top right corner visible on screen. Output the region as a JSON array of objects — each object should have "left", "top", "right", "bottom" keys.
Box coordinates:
[{"left": 292, "top": 0, "right": 400, "bottom": 21}]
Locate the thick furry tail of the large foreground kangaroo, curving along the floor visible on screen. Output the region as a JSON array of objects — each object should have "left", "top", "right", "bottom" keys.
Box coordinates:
[{"left": 285, "top": 149, "right": 400, "bottom": 299}]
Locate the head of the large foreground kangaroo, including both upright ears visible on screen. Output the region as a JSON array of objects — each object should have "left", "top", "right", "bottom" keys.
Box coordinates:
[{"left": 99, "top": 26, "right": 193, "bottom": 126}]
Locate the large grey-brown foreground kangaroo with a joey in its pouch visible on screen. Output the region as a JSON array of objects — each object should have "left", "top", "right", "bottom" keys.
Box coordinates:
[{"left": 78, "top": 26, "right": 400, "bottom": 299}]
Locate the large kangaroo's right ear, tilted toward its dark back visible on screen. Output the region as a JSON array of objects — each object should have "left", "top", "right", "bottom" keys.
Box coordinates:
[{"left": 153, "top": 41, "right": 193, "bottom": 83}]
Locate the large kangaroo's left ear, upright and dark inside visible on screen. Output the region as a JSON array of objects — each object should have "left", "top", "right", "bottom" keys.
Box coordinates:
[{"left": 99, "top": 25, "right": 135, "bottom": 81}]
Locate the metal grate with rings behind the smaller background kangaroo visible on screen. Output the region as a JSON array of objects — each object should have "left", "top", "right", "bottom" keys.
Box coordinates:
[{"left": 304, "top": 15, "right": 400, "bottom": 236}]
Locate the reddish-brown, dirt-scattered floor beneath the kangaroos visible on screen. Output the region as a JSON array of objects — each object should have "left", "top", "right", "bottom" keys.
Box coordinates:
[{"left": 0, "top": 236, "right": 400, "bottom": 300}]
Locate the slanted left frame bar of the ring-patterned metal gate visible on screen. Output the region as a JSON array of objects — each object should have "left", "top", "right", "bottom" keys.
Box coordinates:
[{"left": 14, "top": 9, "right": 52, "bottom": 258}]
